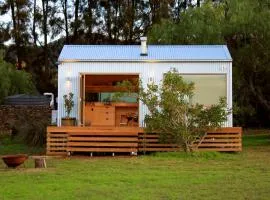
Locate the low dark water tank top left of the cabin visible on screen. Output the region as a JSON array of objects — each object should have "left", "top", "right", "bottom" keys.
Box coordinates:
[{"left": 4, "top": 94, "right": 50, "bottom": 105}]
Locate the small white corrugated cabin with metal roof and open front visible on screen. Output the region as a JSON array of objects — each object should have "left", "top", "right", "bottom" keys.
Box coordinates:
[{"left": 58, "top": 38, "right": 232, "bottom": 127}]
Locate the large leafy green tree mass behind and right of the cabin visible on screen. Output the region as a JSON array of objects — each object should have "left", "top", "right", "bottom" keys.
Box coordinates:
[{"left": 148, "top": 0, "right": 270, "bottom": 127}]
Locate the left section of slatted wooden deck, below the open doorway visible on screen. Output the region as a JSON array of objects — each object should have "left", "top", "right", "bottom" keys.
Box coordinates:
[{"left": 47, "top": 127, "right": 142, "bottom": 155}]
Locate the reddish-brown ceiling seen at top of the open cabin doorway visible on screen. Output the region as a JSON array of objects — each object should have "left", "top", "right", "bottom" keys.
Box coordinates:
[{"left": 85, "top": 75, "right": 139, "bottom": 86}]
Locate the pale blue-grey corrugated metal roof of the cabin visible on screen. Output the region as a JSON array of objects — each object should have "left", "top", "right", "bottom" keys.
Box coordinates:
[{"left": 58, "top": 45, "right": 232, "bottom": 62}]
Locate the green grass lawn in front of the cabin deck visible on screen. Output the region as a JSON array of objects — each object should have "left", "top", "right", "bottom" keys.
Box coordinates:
[{"left": 0, "top": 132, "right": 270, "bottom": 200}]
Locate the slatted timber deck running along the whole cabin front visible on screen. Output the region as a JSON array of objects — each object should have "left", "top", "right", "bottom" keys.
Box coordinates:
[{"left": 47, "top": 126, "right": 242, "bottom": 155}]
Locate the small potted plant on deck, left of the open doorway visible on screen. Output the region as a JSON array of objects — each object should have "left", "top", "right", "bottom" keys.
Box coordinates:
[{"left": 61, "top": 92, "right": 76, "bottom": 126}]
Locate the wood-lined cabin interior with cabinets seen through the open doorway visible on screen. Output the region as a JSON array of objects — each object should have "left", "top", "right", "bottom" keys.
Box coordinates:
[{"left": 81, "top": 74, "right": 139, "bottom": 127}]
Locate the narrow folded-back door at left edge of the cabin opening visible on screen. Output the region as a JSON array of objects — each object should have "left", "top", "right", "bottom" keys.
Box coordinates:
[{"left": 78, "top": 74, "right": 85, "bottom": 126}]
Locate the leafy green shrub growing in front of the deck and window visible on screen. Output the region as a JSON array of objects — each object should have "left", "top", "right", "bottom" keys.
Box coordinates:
[{"left": 139, "top": 69, "right": 229, "bottom": 152}]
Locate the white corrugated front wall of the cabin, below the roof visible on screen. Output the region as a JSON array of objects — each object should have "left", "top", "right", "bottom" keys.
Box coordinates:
[{"left": 58, "top": 61, "right": 232, "bottom": 127}]
